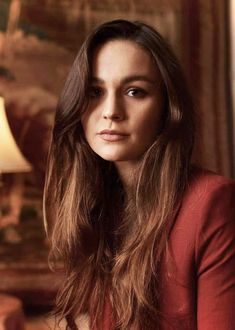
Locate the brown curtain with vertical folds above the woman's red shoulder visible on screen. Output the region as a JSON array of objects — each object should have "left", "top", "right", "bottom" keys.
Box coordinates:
[{"left": 181, "top": 0, "right": 234, "bottom": 176}]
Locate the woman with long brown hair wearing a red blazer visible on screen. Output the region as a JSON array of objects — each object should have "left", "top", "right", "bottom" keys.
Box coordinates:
[{"left": 45, "top": 20, "right": 235, "bottom": 330}]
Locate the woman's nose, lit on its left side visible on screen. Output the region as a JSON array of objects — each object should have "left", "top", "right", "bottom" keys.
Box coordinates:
[{"left": 102, "top": 95, "right": 124, "bottom": 121}]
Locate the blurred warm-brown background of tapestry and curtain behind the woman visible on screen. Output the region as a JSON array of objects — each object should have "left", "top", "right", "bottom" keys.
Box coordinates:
[{"left": 0, "top": 0, "right": 235, "bottom": 329}]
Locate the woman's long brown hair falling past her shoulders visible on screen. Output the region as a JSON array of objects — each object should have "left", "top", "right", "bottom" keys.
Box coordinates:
[{"left": 44, "top": 20, "right": 194, "bottom": 330}]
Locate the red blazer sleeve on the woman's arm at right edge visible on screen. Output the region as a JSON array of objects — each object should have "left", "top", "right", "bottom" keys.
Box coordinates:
[{"left": 195, "top": 181, "right": 235, "bottom": 330}]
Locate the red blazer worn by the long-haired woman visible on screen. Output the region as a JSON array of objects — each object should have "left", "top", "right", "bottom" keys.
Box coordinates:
[{"left": 98, "top": 170, "right": 235, "bottom": 330}]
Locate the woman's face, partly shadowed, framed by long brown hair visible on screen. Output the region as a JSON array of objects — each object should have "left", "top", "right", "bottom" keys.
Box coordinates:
[{"left": 82, "top": 40, "right": 164, "bottom": 162}]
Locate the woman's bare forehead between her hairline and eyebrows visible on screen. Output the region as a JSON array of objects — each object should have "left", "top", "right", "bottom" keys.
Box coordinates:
[{"left": 92, "top": 39, "right": 161, "bottom": 80}]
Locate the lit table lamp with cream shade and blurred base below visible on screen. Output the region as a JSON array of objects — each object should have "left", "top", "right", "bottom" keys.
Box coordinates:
[{"left": 0, "top": 96, "right": 32, "bottom": 242}]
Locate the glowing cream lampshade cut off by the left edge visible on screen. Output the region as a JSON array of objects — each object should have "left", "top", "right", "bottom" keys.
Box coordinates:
[{"left": 0, "top": 96, "right": 32, "bottom": 173}]
